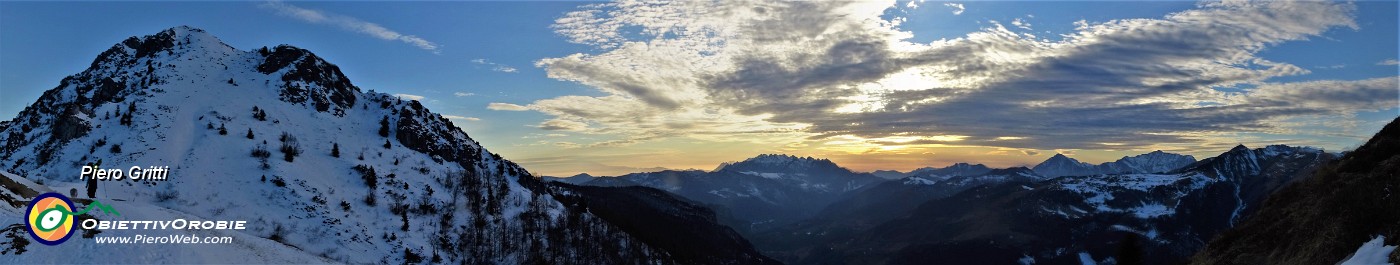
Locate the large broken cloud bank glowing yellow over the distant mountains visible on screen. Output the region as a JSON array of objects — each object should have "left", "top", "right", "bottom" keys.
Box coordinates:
[{"left": 521, "top": 1, "right": 1396, "bottom": 150}]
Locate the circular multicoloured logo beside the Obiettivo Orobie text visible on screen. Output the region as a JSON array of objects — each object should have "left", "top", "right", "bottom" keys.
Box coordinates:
[{"left": 24, "top": 192, "right": 74, "bottom": 245}]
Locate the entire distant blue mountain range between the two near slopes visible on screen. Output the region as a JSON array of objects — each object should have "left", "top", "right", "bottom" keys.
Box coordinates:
[{"left": 540, "top": 146, "right": 1316, "bottom": 264}]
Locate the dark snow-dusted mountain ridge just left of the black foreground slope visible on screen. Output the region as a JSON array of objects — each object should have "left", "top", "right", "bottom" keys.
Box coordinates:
[{"left": 812, "top": 146, "right": 1333, "bottom": 264}]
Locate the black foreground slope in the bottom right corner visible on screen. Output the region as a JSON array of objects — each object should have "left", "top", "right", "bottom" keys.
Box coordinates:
[{"left": 1191, "top": 118, "right": 1400, "bottom": 264}]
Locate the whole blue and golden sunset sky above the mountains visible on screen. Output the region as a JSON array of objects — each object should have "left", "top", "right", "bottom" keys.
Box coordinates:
[{"left": 0, "top": 0, "right": 1400, "bottom": 177}]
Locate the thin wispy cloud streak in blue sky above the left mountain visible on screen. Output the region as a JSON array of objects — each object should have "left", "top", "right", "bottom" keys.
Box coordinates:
[{"left": 258, "top": 0, "right": 440, "bottom": 53}]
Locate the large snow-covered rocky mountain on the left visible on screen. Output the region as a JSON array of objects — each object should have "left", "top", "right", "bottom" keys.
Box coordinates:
[{"left": 0, "top": 27, "right": 711, "bottom": 264}]
